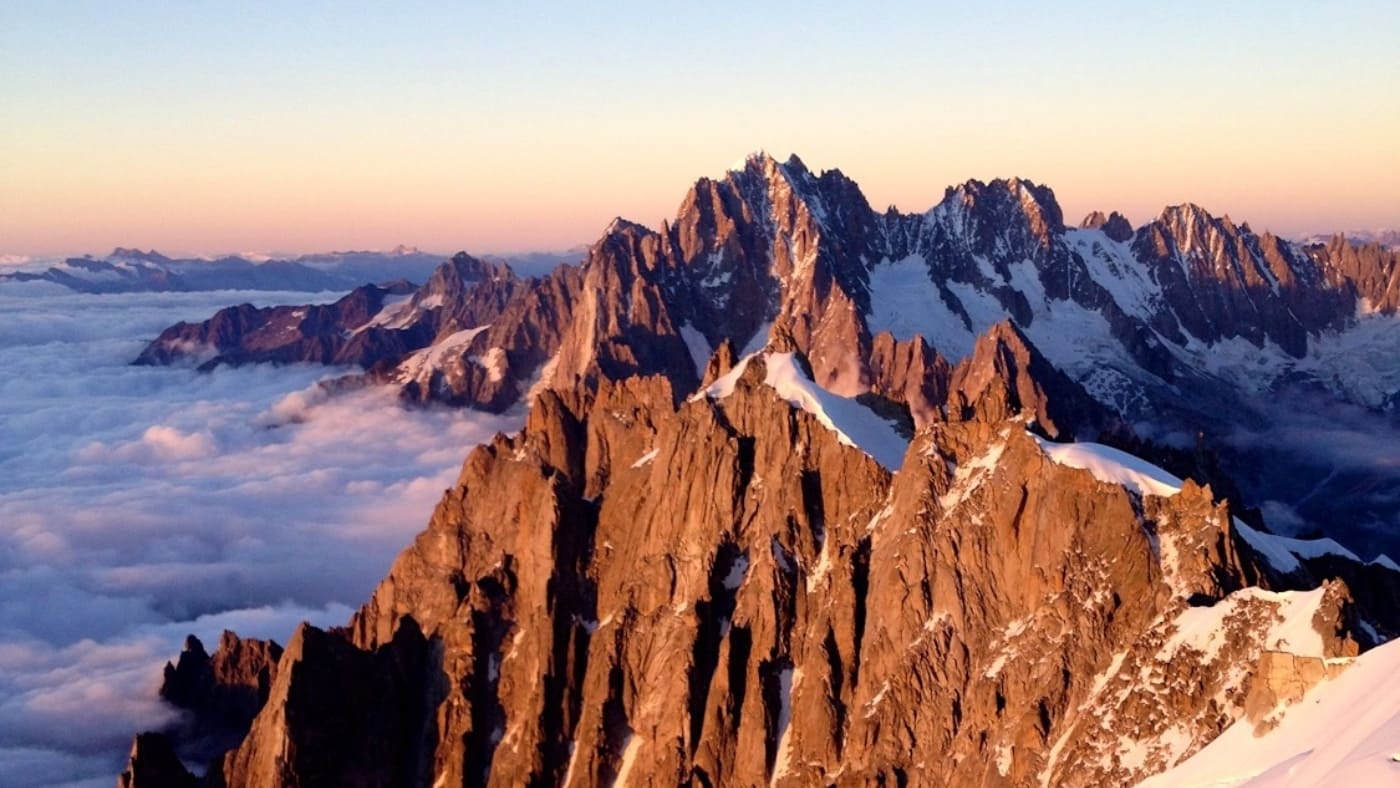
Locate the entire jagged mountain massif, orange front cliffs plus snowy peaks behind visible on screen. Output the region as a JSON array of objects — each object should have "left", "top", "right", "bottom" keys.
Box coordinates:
[{"left": 122, "top": 154, "right": 1400, "bottom": 787}]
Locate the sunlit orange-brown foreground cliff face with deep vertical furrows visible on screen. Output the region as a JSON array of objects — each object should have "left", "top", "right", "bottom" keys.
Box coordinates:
[{"left": 128, "top": 329, "right": 1388, "bottom": 785}]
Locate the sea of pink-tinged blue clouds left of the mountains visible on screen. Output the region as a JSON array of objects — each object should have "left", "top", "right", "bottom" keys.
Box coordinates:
[{"left": 0, "top": 283, "right": 521, "bottom": 787}]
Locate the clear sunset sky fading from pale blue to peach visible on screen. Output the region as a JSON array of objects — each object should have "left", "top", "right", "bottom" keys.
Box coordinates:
[{"left": 0, "top": 0, "right": 1400, "bottom": 256}]
